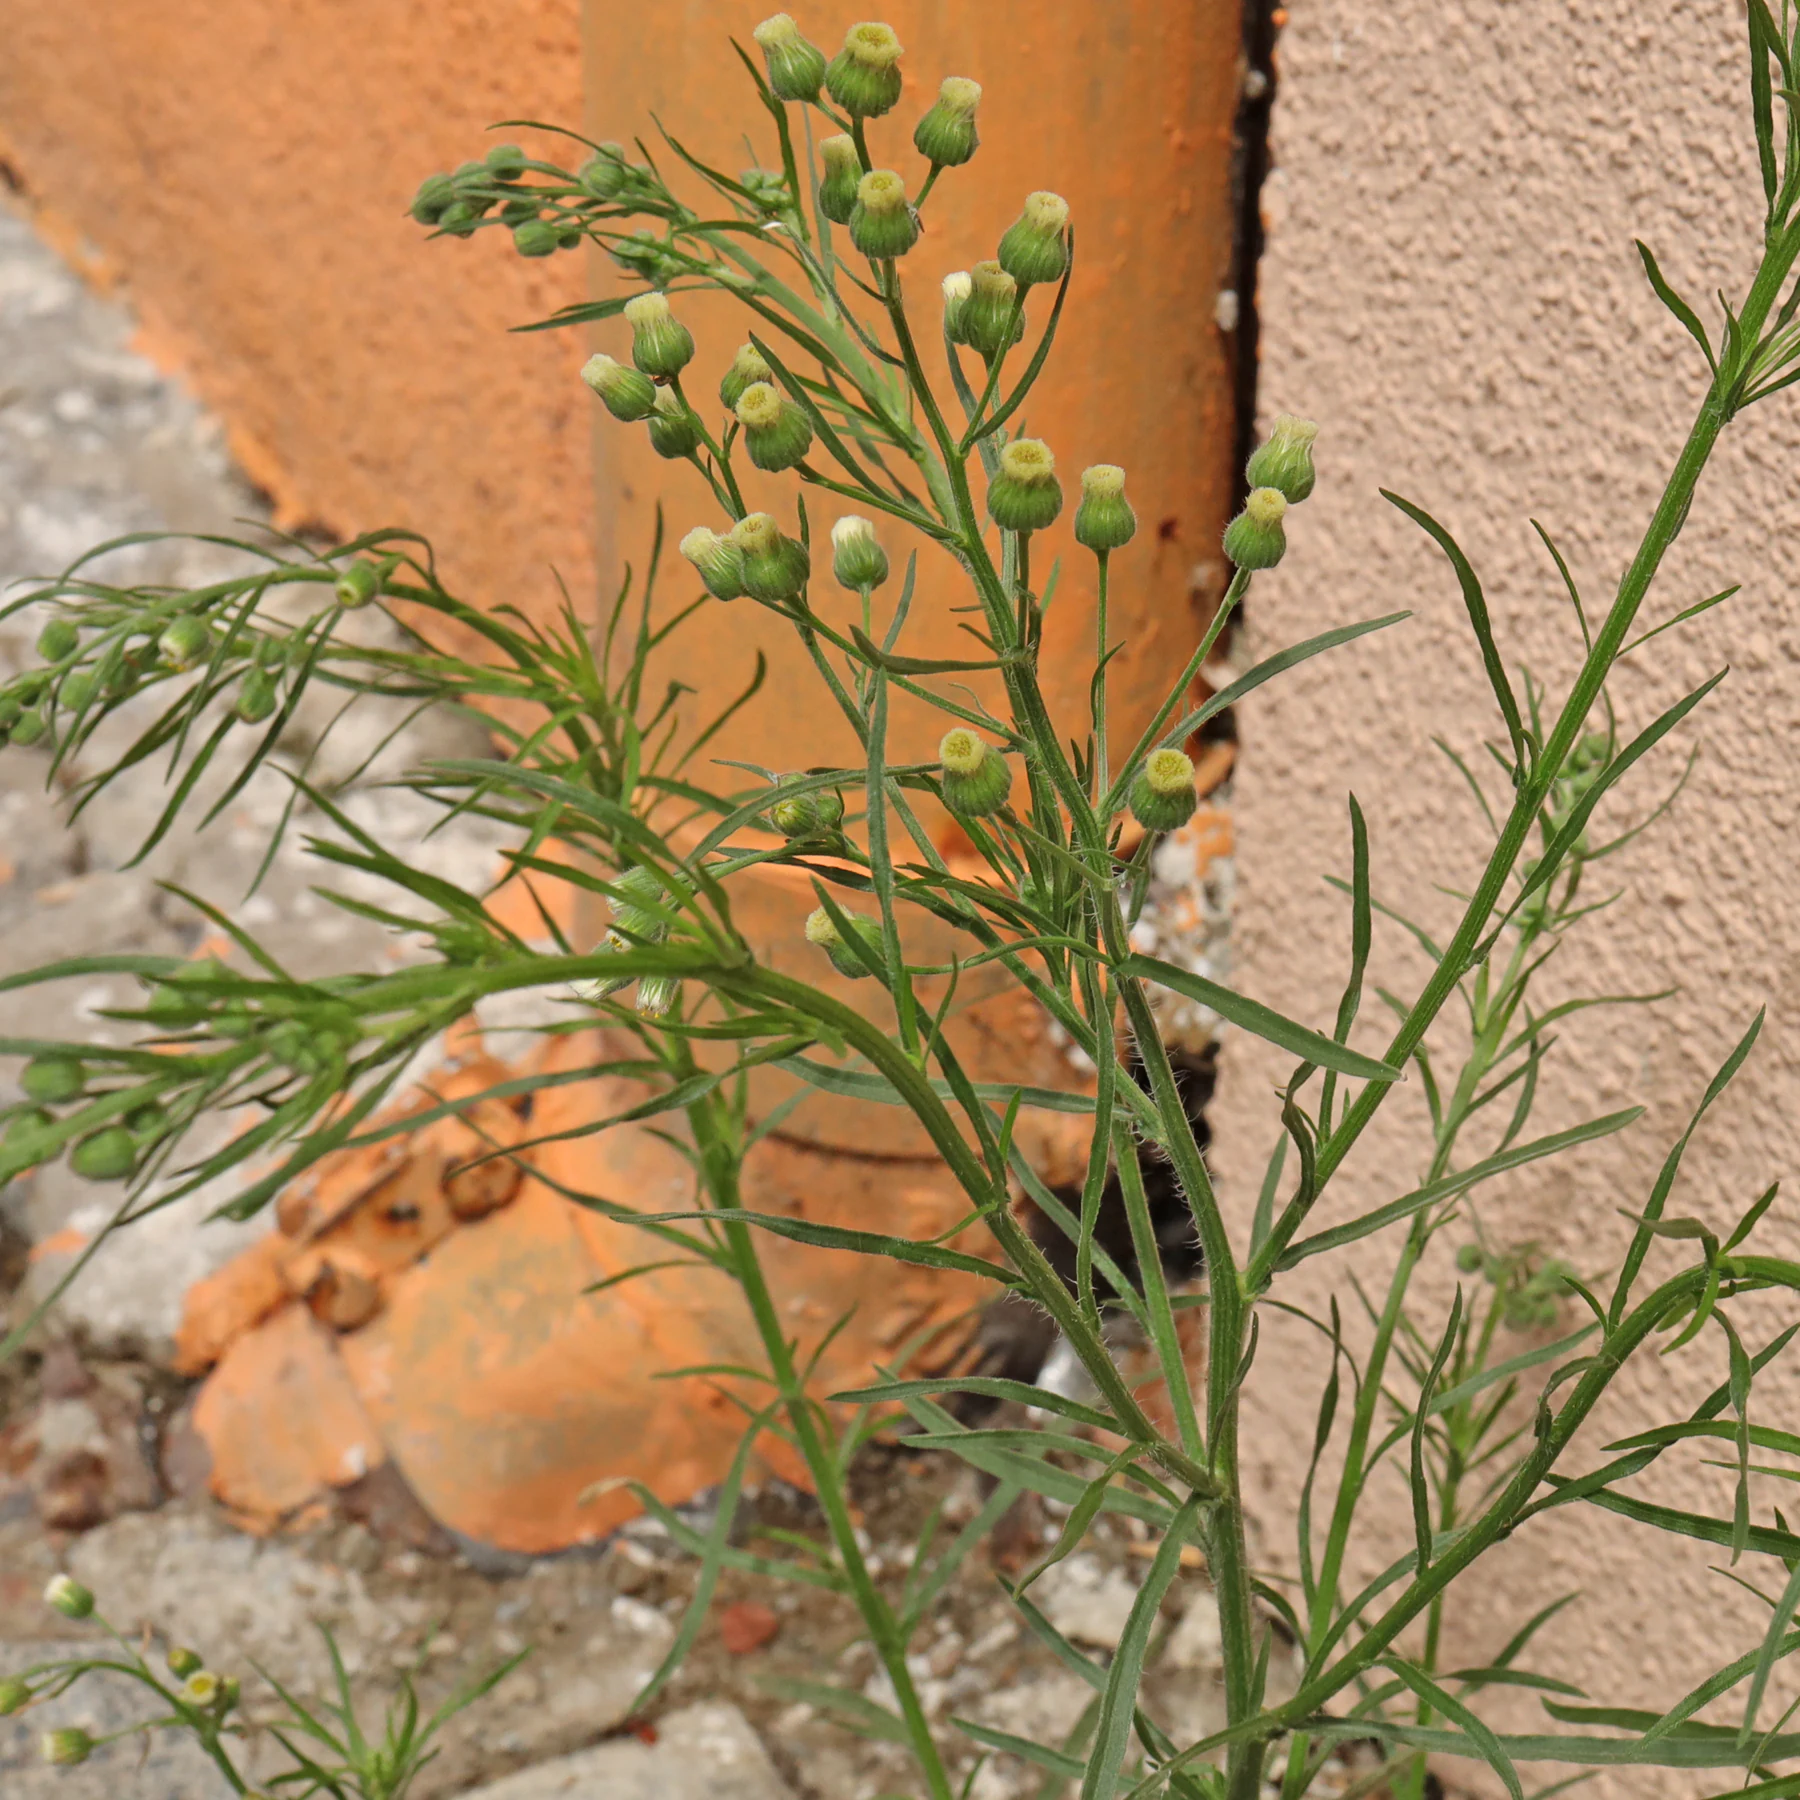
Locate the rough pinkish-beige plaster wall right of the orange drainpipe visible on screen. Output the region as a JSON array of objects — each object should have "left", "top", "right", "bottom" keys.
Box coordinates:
[{"left": 1213, "top": 0, "right": 1800, "bottom": 1795}]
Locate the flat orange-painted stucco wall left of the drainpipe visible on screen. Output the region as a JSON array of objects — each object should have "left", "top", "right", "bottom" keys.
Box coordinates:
[{"left": 0, "top": 0, "right": 594, "bottom": 605}]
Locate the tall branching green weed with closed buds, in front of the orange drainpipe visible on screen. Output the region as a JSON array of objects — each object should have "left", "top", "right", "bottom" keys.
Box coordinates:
[{"left": 10, "top": 10, "right": 1800, "bottom": 1800}]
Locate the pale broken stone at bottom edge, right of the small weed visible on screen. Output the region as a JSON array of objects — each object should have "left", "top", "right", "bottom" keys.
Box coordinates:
[{"left": 448, "top": 1701, "right": 792, "bottom": 1800}]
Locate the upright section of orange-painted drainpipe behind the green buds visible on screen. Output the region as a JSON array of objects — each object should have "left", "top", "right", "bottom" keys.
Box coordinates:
[{"left": 587, "top": 0, "right": 1240, "bottom": 769}]
